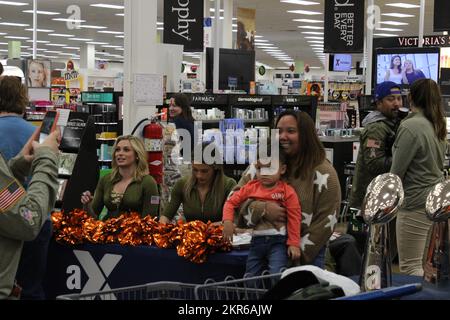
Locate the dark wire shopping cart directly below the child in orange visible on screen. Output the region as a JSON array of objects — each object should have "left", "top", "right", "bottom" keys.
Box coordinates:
[{"left": 194, "top": 273, "right": 281, "bottom": 300}]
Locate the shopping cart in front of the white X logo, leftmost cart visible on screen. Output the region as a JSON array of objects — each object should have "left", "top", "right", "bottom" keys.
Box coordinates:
[{"left": 56, "top": 281, "right": 196, "bottom": 300}]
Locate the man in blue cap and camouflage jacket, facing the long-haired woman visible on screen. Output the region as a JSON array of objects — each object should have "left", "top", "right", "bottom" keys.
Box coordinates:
[{"left": 350, "top": 81, "right": 403, "bottom": 209}]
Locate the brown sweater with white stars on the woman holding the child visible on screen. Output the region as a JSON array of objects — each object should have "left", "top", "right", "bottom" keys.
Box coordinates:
[{"left": 238, "top": 160, "right": 341, "bottom": 264}]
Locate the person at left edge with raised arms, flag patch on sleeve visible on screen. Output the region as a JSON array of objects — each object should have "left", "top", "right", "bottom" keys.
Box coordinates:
[{"left": 0, "top": 130, "right": 60, "bottom": 300}]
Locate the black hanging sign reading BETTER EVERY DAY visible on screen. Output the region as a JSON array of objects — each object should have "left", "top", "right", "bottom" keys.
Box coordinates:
[{"left": 323, "top": 0, "right": 365, "bottom": 53}]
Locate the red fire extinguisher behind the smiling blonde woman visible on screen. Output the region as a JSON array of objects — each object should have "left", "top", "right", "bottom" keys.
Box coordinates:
[{"left": 144, "top": 120, "right": 164, "bottom": 184}]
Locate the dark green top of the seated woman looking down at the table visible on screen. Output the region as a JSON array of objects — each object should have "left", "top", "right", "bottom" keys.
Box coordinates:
[{"left": 163, "top": 176, "right": 236, "bottom": 222}]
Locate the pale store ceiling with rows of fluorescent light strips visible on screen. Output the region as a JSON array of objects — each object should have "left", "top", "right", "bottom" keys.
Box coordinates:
[{"left": 0, "top": 0, "right": 442, "bottom": 68}]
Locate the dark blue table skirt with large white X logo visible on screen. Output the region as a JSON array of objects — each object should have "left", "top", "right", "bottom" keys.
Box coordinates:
[{"left": 44, "top": 240, "right": 248, "bottom": 299}]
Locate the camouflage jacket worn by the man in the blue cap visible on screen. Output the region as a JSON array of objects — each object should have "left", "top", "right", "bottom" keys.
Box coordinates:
[{"left": 350, "top": 111, "right": 396, "bottom": 209}]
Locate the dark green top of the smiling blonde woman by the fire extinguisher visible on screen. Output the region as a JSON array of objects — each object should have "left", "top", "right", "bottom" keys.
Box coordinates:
[{"left": 92, "top": 174, "right": 160, "bottom": 219}]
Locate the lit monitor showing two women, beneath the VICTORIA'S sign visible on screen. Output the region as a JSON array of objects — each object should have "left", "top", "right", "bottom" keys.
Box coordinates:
[{"left": 373, "top": 48, "right": 440, "bottom": 87}]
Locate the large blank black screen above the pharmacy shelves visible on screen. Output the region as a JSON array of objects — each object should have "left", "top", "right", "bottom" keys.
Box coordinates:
[{"left": 206, "top": 48, "right": 255, "bottom": 93}]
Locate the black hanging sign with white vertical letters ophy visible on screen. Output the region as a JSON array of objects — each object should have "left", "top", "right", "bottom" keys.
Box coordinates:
[{"left": 164, "top": 0, "right": 204, "bottom": 52}]
